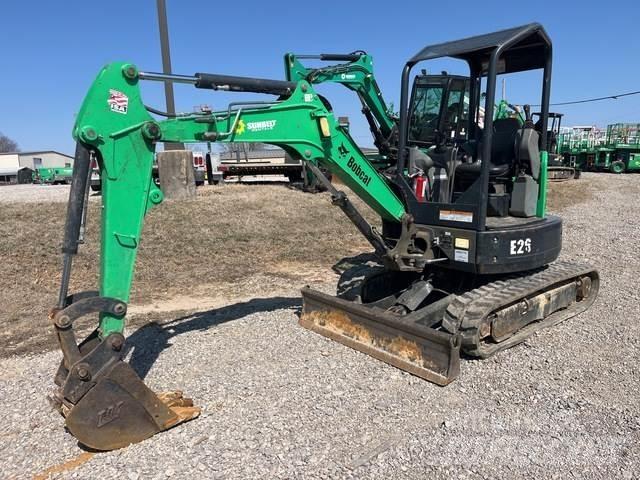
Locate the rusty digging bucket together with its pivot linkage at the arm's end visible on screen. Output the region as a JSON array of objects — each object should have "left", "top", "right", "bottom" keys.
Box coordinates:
[{"left": 50, "top": 292, "right": 200, "bottom": 450}]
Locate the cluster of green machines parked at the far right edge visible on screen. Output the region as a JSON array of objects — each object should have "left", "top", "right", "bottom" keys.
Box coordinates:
[{"left": 558, "top": 123, "right": 640, "bottom": 173}]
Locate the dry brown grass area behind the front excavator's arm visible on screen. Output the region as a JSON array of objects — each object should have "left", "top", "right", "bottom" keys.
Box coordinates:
[{"left": 0, "top": 178, "right": 595, "bottom": 356}]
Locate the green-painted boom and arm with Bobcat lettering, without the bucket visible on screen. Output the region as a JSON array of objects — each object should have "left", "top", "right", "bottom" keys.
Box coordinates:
[{"left": 73, "top": 63, "right": 405, "bottom": 335}]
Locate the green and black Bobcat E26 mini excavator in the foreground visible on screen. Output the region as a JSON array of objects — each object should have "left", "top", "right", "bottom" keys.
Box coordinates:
[{"left": 50, "top": 24, "right": 598, "bottom": 450}]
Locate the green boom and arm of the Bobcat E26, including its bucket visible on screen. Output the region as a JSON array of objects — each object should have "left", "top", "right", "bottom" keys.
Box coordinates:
[{"left": 50, "top": 63, "right": 405, "bottom": 450}]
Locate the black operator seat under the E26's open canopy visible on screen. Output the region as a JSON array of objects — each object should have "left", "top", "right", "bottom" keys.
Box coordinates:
[{"left": 456, "top": 118, "right": 522, "bottom": 177}]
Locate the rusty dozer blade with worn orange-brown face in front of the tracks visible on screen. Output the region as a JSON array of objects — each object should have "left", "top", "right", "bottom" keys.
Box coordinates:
[{"left": 299, "top": 288, "right": 460, "bottom": 385}]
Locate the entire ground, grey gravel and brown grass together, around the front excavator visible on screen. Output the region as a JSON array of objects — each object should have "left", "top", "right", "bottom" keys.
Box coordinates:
[{"left": 0, "top": 174, "right": 640, "bottom": 479}]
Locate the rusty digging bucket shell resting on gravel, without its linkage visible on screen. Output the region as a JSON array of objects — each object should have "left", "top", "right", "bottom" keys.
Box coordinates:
[{"left": 62, "top": 361, "right": 200, "bottom": 450}]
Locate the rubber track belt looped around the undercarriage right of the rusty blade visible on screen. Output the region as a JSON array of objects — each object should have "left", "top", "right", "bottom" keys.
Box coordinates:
[{"left": 443, "top": 261, "right": 599, "bottom": 358}]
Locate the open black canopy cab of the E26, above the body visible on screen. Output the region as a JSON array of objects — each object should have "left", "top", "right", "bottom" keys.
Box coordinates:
[{"left": 398, "top": 24, "right": 551, "bottom": 221}]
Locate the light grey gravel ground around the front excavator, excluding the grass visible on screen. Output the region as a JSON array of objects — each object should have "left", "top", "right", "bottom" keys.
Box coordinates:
[{"left": 0, "top": 174, "right": 640, "bottom": 480}]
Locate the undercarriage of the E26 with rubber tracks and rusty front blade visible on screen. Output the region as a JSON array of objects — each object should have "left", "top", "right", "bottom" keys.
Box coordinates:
[{"left": 300, "top": 261, "right": 599, "bottom": 385}]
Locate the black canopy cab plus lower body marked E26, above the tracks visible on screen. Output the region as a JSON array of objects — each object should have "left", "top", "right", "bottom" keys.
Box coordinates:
[{"left": 383, "top": 23, "right": 561, "bottom": 273}]
